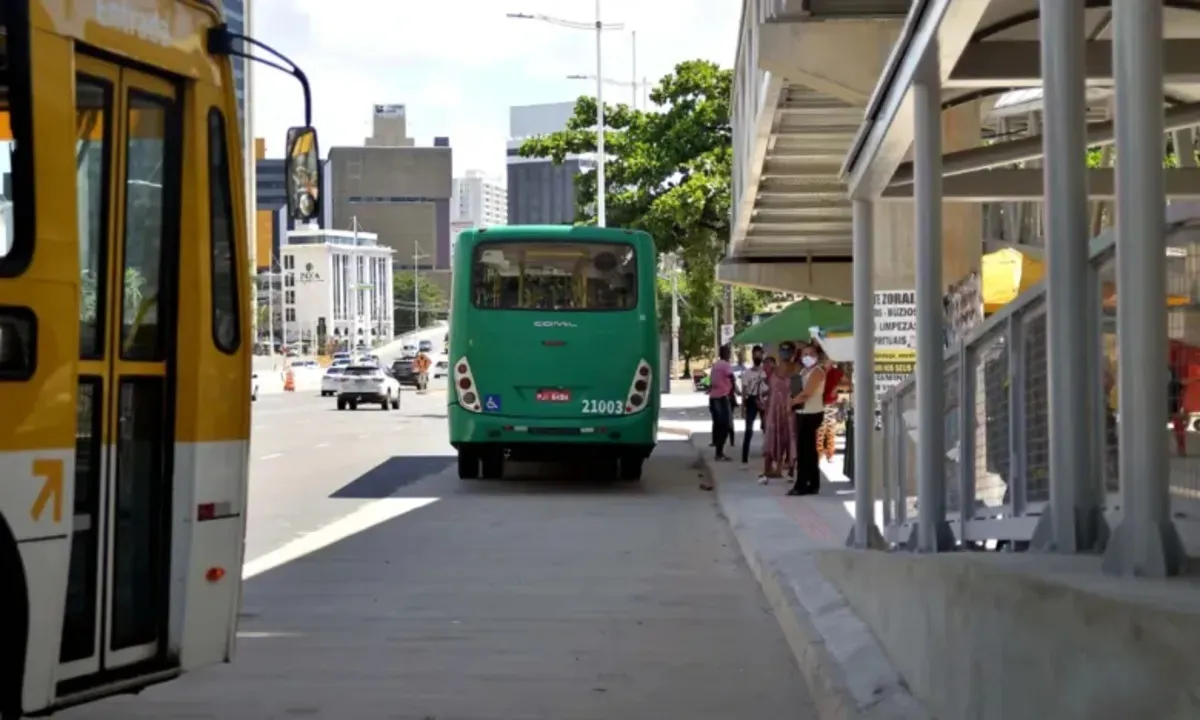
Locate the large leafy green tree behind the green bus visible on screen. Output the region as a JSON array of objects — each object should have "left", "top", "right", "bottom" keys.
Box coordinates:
[{"left": 521, "top": 60, "right": 769, "bottom": 358}]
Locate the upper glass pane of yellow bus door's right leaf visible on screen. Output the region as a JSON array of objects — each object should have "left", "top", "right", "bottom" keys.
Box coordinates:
[{"left": 121, "top": 91, "right": 178, "bottom": 361}]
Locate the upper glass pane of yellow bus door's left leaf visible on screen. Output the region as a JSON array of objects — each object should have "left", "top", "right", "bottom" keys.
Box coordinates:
[{"left": 76, "top": 77, "right": 112, "bottom": 359}]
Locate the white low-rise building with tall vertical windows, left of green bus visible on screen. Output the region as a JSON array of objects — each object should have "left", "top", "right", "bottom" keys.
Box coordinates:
[{"left": 280, "top": 229, "right": 395, "bottom": 349}]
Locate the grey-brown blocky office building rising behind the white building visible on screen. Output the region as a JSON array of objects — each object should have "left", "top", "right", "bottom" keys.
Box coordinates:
[{"left": 325, "top": 106, "right": 452, "bottom": 289}]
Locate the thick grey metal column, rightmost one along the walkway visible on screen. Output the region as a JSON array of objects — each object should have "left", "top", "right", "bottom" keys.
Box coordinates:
[{"left": 1104, "top": 0, "right": 1183, "bottom": 577}]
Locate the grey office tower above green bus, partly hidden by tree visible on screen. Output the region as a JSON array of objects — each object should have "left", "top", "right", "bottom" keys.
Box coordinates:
[{"left": 508, "top": 102, "right": 594, "bottom": 224}]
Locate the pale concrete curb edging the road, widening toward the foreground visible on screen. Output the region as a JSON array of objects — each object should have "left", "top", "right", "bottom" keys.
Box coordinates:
[{"left": 694, "top": 432, "right": 930, "bottom": 720}]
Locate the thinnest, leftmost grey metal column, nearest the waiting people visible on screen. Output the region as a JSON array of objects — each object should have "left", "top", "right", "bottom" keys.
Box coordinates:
[{"left": 846, "top": 199, "right": 887, "bottom": 550}]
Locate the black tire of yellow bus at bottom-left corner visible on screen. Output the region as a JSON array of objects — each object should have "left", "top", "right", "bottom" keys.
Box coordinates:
[{"left": 0, "top": 516, "right": 29, "bottom": 720}]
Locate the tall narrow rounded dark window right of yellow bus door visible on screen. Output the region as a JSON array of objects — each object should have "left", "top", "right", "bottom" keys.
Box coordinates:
[{"left": 209, "top": 108, "right": 241, "bottom": 354}]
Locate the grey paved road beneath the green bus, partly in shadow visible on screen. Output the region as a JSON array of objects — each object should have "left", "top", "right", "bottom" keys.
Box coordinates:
[{"left": 61, "top": 394, "right": 816, "bottom": 720}]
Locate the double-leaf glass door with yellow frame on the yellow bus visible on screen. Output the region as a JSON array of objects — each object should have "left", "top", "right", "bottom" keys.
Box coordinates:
[{"left": 59, "top": 55, "right": 182, "bottom": 696}]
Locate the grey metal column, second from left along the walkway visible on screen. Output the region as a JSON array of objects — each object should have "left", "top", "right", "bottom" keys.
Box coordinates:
[{"left": 908, "top": 42, "right": 954, "bottom": 552}]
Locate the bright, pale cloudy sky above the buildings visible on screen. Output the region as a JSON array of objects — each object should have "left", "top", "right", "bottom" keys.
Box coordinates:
[{"left": 251, "top": 0, "right": 743, "bottom": 178}]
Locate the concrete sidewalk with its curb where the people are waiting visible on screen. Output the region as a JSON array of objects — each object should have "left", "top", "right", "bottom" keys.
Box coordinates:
[{"left": 660, "top": 420, "right": 929, "bottom": 720}]
